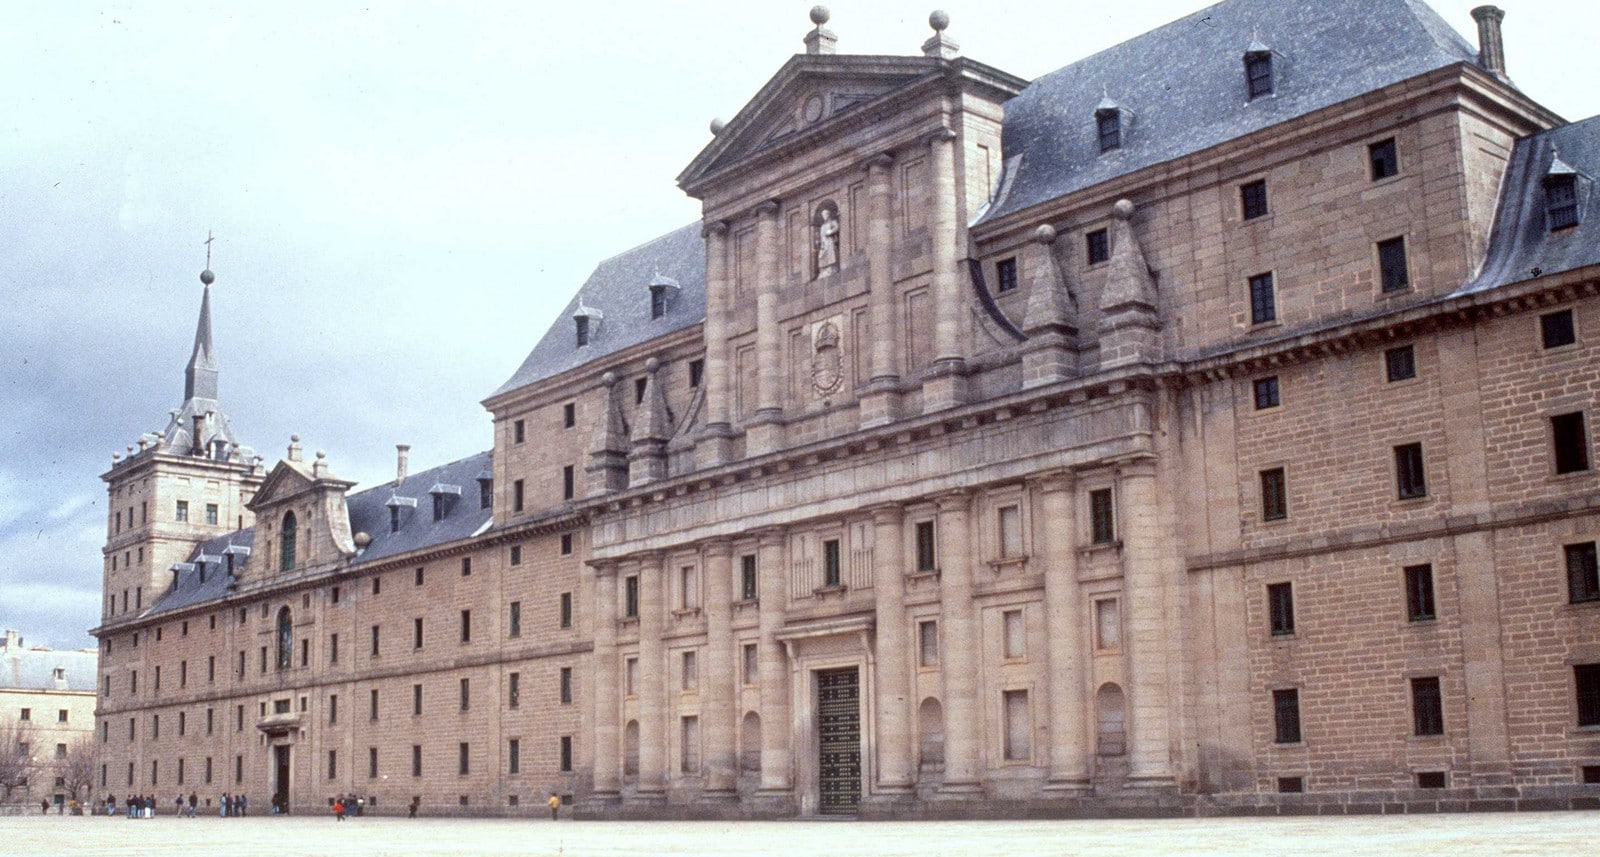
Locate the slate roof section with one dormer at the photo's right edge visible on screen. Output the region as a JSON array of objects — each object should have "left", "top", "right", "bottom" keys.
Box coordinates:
[{"left": 1458, "top": 117, "right": 1600, "bottom": 294}]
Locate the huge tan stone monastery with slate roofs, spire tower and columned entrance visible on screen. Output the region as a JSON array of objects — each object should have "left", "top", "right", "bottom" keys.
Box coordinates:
[{"left": 94, "top": 0, "right": 1600, "bottom": 817}]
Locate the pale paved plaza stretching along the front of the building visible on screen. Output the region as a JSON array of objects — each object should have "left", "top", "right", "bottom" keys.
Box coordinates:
[{"left": 0, "top": 812, "right": 1600, "bottom": 857}]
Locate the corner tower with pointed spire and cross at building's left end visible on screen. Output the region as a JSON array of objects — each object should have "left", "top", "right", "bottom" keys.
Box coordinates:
[{"left": 101, "top": 254, "right": 262, "bottom": 624}]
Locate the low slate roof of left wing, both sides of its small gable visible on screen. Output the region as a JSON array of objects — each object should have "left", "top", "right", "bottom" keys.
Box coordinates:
[{"left": 150, "top": 451, "right": 493, "bottom": 617}]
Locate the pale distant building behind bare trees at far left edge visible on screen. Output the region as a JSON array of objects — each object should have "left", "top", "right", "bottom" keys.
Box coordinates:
[{"left": 0, "top": 630, "right": 99, "bottom": 812}]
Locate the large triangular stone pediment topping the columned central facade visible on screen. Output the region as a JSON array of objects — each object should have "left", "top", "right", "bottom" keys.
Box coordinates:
[{"left": 678, "top": 54, "right": 941, "bottom": 187}]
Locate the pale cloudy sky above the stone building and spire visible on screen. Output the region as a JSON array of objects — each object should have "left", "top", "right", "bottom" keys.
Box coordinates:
[{"left": 0, "top": 0, "right": 1600, "bottom": 646}]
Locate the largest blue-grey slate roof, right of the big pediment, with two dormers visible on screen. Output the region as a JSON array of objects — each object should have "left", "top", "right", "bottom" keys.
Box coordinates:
[{"left": 982, "top": 0, "right": 1477, "bottom": 221}]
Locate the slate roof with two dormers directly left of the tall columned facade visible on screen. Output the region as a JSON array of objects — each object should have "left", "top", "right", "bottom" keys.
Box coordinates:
[{"left": 489, "top": 221, "right": 706, "bottom": 402}]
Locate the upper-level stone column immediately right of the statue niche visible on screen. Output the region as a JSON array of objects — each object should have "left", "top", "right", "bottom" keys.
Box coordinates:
[{"left": 856, "top": 155, "right": 904, "bottom": 427}]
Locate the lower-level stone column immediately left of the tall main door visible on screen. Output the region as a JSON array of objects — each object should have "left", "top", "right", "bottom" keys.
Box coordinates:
[{"left": 755, "top": 529, "right": 794, "bottom": 796}]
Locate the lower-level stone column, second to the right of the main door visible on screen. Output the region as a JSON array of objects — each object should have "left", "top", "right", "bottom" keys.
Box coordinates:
[{"left": 934, "top": 491, "right": 982, "bottom": 795}]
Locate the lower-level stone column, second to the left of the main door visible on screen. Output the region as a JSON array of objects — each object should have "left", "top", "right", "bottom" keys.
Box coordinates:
[{"left": 699, "top": 539, "right": 739, "bottom": 799}]
